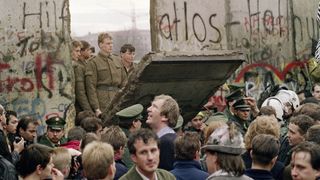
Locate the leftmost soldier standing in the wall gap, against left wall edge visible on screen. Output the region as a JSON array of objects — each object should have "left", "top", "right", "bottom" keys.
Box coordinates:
[{"left": 73, "top": 41, "right": 92, "bottom": 114}]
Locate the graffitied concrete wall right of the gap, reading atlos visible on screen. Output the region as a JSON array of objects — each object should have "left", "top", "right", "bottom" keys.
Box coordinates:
[{"left": 150, "top": 0, "right": 319, "bottom": 96}]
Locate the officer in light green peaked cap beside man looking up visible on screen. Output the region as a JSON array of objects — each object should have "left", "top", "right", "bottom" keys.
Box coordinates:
[{"left": 116, "top": 104, "right": 143, "bottom": 168}]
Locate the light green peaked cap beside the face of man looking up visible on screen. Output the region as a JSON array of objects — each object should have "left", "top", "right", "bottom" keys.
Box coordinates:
[{"left": 116, "top": 104, "right": 143, "bottom": 120}]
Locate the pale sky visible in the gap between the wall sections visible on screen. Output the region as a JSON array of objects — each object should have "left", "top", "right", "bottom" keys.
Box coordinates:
[{"left": 70, "top": 0, "right": 150, "bottom": 36}]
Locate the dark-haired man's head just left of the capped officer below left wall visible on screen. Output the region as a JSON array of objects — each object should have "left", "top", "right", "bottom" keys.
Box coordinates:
[{"left": 17, "top": 116, "right": 38, "bottom": 142}]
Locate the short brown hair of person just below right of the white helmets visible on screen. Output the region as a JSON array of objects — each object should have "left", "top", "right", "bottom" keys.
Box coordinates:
[{"left": 290, "top": 114, "right": 314, "bottom": 135}]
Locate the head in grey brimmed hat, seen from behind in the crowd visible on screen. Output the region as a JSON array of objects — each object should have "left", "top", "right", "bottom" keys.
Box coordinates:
[{"left": 202, "top": 123, "right": 245, "bottom": 176}]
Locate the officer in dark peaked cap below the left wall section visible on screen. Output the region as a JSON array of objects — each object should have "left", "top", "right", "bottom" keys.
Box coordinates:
[{"left": 38, "top": 116, "right": 67, "bottom": 147}]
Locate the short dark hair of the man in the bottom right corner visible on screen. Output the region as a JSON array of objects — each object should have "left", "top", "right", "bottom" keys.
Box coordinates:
[{"left": 292, "top": 141, "right": 320, "bottom": 171}]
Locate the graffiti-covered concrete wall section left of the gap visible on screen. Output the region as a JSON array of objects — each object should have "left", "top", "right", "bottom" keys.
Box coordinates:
[{"left": 0, "top": 0, "right": 74, "bottom": 124}]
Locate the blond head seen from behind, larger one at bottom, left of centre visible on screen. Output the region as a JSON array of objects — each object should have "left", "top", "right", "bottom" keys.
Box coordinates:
[{"left": 82, "top": 141, "right": 116, "bottom": 180}]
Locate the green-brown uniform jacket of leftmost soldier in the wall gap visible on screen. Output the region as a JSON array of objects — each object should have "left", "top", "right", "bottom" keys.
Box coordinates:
[{"left": 74, "top": 60, "right": 92, "bottom": 111}]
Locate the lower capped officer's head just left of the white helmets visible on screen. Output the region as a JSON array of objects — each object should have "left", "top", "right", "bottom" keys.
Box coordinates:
[{"left": 233, "top": 99, "right": 251, "bottom": 121}]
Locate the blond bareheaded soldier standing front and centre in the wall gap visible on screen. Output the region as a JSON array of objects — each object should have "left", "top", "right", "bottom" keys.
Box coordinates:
[{"left": 85, "top": 33, "right": 126, "bottom": 116}]
